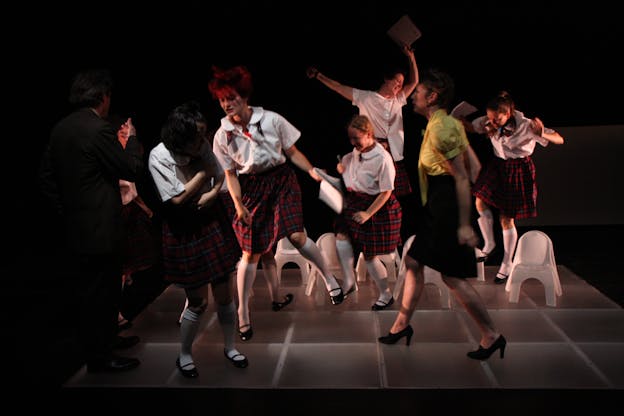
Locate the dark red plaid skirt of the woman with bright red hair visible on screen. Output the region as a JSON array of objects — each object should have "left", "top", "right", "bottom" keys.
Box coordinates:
[{"left": 232, "top": 163, "right": 303, "bottom": 254}]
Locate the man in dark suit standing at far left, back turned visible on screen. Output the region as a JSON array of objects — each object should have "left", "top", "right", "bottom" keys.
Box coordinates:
[{"left": 40, "top": 70, "right": 144, "bottom": 372}]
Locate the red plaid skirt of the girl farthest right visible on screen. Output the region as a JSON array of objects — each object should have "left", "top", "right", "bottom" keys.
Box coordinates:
[{"left": 472, "top": 156, "right": 537, "bottom": 219}]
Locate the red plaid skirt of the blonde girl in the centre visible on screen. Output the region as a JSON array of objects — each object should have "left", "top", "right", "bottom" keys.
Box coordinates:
[{"left": 334, "top": 192, "right": 402, "bottom": 257}]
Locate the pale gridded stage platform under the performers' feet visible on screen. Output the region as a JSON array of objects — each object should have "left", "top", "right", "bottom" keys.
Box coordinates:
[{"left": 64, "top": 266, "right": 624, "bottom": 390}]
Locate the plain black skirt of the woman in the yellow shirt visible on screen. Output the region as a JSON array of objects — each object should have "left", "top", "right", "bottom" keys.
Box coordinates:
[{"left": 408, "top": 175, "right": 477, "bottom": 278}]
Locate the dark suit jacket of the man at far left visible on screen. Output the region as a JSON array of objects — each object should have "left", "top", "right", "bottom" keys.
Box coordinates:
[{"left": 40, "top": 108, "right": 143, "bottom": 254}]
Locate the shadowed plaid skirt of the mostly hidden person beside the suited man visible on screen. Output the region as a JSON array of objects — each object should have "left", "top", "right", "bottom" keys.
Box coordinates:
[{"left": 121, "top": 202, "right": 160, "bottom": 274}]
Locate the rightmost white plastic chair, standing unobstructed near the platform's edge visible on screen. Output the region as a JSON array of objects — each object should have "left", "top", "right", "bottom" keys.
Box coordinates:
[{"left": 505, "top": 230, "right": 563, "bottom": 306}]
